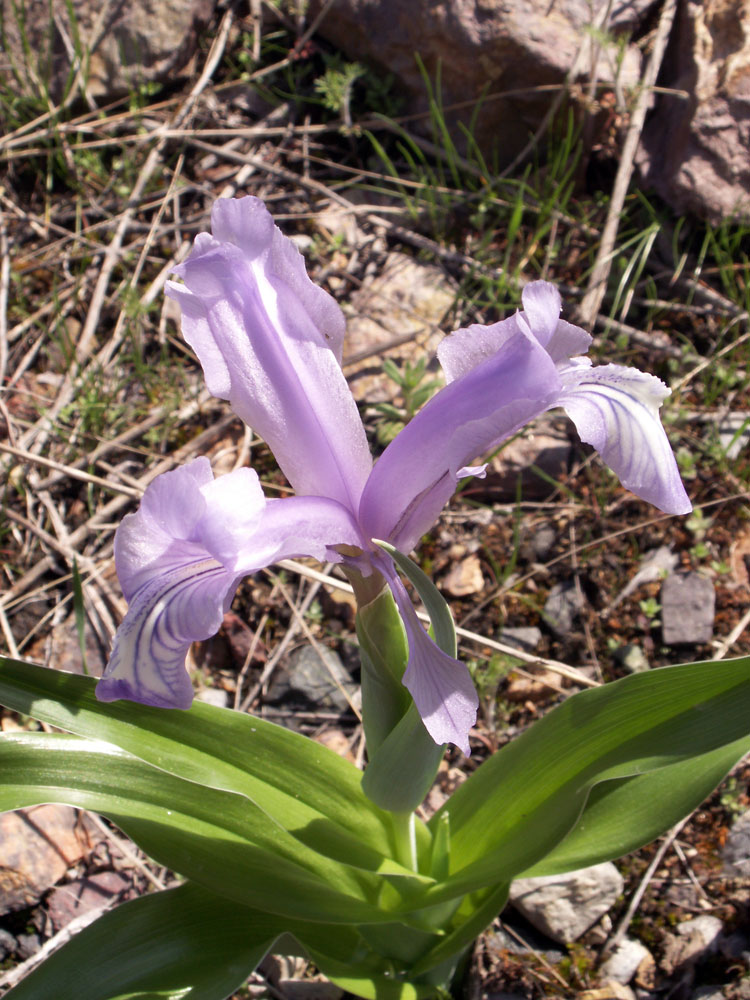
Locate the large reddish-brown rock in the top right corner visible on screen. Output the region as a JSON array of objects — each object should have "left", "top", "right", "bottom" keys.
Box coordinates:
[{"left": 638, "top": 0, "right": 750, "bottom": 222}]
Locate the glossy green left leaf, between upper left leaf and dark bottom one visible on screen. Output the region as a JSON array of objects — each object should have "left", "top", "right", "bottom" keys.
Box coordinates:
[{"left": 0, "top": 733, "right": 408, "bottom": 923}]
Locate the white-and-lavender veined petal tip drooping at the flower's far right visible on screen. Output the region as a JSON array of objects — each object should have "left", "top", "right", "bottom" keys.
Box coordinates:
[{"left": 558, "top": 359, "right": 692, "bottom": 514}]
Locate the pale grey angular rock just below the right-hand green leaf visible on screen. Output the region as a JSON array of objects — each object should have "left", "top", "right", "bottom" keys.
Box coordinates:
[{"left": 510, "top": 861, "right": 624, "bottom": 944}]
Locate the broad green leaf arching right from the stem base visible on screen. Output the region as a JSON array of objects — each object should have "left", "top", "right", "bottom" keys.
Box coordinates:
[{"left": 426, "top": 657, "right": 750, "bottom": 902}]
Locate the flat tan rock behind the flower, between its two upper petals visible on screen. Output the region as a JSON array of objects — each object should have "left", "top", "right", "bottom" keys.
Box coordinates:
[{"left": 344, "top": 252, "right": 455, "bottom": 404}]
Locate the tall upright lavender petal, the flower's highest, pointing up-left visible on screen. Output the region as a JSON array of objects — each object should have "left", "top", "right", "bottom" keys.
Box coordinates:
[{"left": 167, "top": 197, "right": 372, "bottom": 510}]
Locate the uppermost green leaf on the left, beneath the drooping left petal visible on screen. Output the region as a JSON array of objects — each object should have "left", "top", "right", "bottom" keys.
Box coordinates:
[{"left": 0, "top": 657, "right": 400, "bottom": 870}]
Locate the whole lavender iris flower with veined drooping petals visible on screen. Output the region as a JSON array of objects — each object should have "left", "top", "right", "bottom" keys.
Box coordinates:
[{"left": 97, "top": 197, "right": 690, "bottom": 752}]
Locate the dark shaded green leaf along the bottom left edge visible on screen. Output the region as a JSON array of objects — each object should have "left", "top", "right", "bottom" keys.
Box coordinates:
[{"left": 4, "top": 882, "right": 434, "bottom": 1000}]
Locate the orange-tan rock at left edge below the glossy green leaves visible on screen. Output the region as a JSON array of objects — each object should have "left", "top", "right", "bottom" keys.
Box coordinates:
[{"left": 0, "top": 805, "right": 99, "bottom": 914}]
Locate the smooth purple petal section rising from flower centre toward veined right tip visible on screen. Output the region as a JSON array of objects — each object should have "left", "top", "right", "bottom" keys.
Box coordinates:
[{"left": 360, "top": 328, "right": 560, "bottom": 552}]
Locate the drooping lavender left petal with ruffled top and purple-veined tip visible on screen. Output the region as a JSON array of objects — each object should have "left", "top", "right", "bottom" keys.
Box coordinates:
[{"left": 96, "top": 458, "right": 361, "bottom": 708}]
